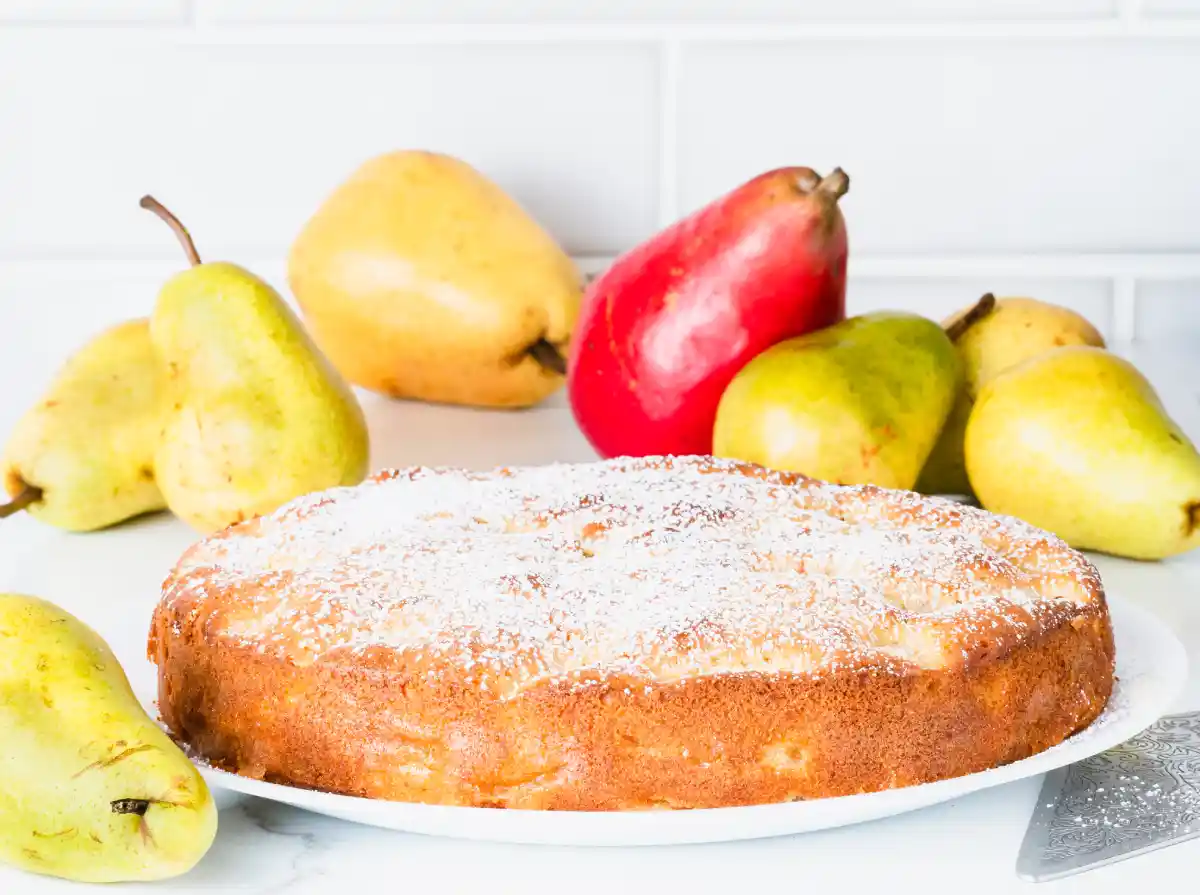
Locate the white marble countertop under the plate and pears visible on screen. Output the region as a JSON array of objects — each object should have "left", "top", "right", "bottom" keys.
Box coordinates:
[{"left": 0, "top": 346, "right": 1200, "bottom": 895}]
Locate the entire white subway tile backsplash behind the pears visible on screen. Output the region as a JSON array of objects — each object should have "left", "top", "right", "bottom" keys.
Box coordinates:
[{"left": 0, "top": 8, "right": 1200, "bottom": 345}]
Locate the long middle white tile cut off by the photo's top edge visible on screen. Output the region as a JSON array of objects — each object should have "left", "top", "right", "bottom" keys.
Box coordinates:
[{"left": 197, "top": 0, "right": 1117, "bottom": 24}]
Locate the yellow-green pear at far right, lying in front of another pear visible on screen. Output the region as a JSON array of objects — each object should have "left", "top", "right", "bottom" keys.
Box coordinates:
[{"left": 965, "top": 346, "right": 1200, "bottom": 559}]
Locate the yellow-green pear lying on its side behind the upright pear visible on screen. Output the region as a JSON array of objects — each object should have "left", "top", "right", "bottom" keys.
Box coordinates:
[{"left": 0, "top": 319, "right": 164, "bottom": 531}]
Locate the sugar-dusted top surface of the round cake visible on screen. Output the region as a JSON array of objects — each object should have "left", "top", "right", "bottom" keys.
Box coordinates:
[{"left": 163, "top": 457, "right": 1103, "bottom": 697}]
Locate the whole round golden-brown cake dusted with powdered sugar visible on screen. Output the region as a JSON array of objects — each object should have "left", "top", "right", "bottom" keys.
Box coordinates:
[{"left": 149, "top": 457, "right": 1114, "bottom": 811}]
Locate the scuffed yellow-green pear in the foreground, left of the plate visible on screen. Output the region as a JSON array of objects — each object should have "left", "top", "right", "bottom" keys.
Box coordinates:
[{"left": 0, "top": 594, "right": 217, "bottom": 883}]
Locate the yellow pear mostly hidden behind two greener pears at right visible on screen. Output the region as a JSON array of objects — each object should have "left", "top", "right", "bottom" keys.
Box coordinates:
[{"left": 917, "top": 293, "right": 1104, "bottom": 495}]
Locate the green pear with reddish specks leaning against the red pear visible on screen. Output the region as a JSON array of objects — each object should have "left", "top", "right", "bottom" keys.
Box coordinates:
[{"left": 713, "top": 311, "right": 960, "bottom": 488}]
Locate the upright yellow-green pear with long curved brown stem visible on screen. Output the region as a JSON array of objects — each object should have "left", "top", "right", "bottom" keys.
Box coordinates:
[{"left": 142, "top": 197, "right": 370, "bottom": 533}]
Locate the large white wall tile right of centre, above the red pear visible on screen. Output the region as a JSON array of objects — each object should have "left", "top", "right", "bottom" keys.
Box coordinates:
[{"left": 678, "top": 40, "right": 1200, "bottom": 253}]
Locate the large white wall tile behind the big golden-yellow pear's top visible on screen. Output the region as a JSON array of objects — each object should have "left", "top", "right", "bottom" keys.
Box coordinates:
[{"left": 0, "top": 38, "right": 659, "bottom": 256}]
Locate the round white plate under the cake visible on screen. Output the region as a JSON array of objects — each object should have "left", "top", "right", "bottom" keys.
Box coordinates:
[{"left": 192, "top": 596, "right": 1187, "bottom": 846}]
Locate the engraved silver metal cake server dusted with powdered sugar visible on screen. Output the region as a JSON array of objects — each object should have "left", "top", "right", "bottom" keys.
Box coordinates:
[{"left": 1016, "top": 711, "right": 1200, "bottom": 882}]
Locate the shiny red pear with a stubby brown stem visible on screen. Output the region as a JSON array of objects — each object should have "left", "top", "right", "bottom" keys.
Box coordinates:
[{"left": 568, "top": 167, "right": 850, "bottom": 457}]
